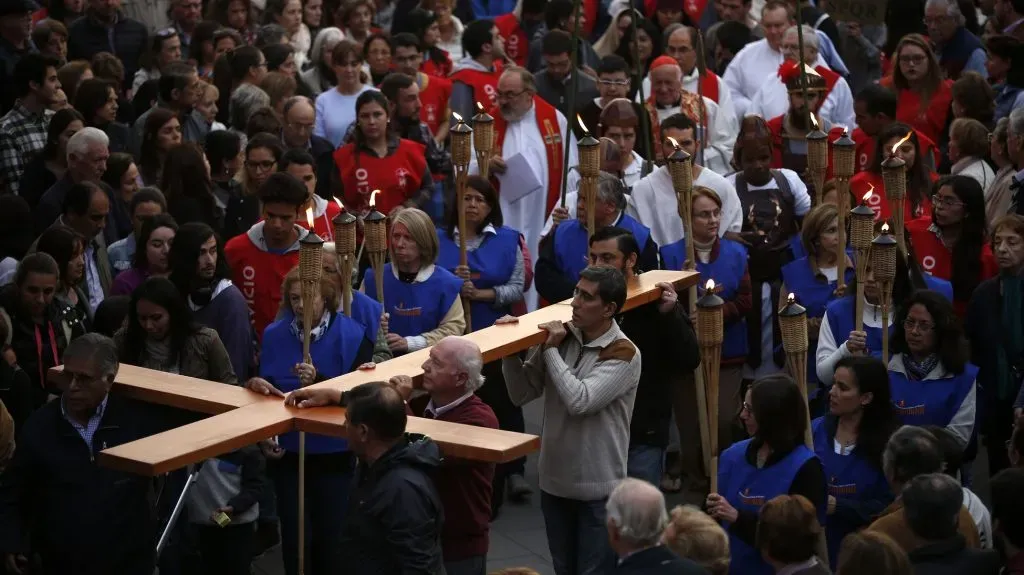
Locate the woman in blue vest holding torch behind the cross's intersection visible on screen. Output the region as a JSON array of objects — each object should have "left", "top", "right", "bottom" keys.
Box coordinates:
[{"left": 246, "top": 267, "right": 373, "bottom": 575}]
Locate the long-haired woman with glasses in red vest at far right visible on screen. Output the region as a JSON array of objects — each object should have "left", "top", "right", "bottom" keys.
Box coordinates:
[{"left": 907, "top": 176, "right": 997, "bottom": 317}]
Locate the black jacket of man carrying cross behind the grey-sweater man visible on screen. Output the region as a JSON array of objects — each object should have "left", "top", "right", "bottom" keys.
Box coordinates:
[{"left": 617, "top": 300, "right": 700, "bottom": 447}]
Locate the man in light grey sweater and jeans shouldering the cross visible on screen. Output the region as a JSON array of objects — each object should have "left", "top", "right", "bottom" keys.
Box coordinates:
[{"left": 499, "top": 267, "right": 640, "bottom": 575}]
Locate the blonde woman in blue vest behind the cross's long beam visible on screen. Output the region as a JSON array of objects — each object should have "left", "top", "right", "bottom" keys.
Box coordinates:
[{"left": 361, "top": 203, "right": 466, "bottom": 355}]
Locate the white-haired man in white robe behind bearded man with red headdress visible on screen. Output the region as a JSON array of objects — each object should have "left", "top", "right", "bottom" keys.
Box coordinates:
[{"left": 749, "top": 25, "right": 857, "bottom": 129}]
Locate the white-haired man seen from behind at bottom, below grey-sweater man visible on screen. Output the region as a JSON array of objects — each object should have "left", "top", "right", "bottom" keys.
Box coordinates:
[{"left": 605, "top": 478, "right": 708, "bottom": 575}]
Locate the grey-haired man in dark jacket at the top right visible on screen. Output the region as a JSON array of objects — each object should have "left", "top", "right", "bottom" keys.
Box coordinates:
[{"left": 925, "top": 0, "right": 988, "bottom": 81}]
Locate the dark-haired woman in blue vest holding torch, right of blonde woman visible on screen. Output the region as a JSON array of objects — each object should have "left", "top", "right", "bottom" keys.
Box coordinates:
[{"left": 437, "top": 176, "right": 530, "bottom": 505}]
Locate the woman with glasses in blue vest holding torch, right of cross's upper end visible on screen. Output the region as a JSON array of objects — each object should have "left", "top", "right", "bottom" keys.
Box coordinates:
[{"left": 660, "top": 186, "right": 752, "bottom": 452}]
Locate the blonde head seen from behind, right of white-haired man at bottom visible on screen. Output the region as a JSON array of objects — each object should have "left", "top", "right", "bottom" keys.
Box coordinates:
[{"left": 662, "top": 505, "right": 729, "bottom": 575}]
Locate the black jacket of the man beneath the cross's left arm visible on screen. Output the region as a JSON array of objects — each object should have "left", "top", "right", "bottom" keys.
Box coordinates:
[{"left": 0, "top": 395, "right": 160, "bottom": 575}]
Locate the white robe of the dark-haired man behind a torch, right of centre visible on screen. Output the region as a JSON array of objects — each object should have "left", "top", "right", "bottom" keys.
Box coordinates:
[{"left": 626, "top": 166, "right": 743, "bottom": 247}]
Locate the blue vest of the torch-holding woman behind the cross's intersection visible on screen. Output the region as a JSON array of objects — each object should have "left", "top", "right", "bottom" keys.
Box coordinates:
[{"left": 259, "top": 313, "right": 365, "bottom": 453}]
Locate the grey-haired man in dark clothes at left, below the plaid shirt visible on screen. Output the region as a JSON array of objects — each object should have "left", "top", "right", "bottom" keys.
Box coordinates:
[{"left": 35, "top": 128, "right": 111, "bottom": 233}]
